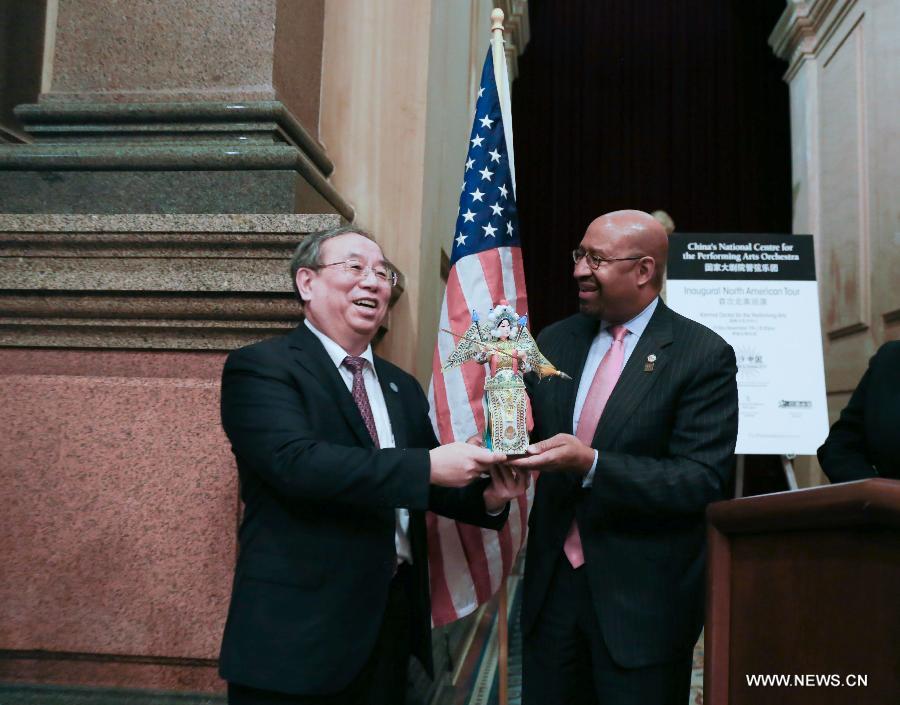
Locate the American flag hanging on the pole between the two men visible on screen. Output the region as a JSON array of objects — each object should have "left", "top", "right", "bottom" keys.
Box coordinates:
[{"left": 428, "top": 49, "right": 528, "bottom": 626}]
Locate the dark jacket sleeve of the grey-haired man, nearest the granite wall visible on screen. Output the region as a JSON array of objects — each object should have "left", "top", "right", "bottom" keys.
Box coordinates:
[{"left": 221, "top": 348, "right": 431, "bottom": 509}]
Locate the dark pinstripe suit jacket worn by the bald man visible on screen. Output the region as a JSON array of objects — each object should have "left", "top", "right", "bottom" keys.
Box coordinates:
[{"left": 522, "top": 301, "right": 738, "bottom": 667}]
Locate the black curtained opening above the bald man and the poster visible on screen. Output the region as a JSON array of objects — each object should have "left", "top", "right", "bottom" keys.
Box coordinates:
[{"left": 512, "top": 0, "right": 791, "bottom": 332}]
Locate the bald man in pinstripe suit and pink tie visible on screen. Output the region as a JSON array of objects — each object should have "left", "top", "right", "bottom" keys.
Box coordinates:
[{"left": 512, "top": 210, "right": 738, "bottom": 705}]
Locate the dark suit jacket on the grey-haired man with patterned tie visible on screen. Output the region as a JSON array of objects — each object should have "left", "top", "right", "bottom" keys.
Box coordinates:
[{"left": 214, "top": 324, "right": 507, "bottom": 694}]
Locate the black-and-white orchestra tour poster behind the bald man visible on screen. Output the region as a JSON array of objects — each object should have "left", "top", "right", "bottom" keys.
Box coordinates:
[{"left": 666, "top": 233, "right": 828, "bottom": 455}]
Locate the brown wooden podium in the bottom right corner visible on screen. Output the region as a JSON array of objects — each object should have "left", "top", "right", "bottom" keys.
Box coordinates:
[{"left": 703, "top": 479, "right": 900, "bottom": 705}]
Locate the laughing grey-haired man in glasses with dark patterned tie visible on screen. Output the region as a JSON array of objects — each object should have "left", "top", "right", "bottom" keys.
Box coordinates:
[{"left": 220, "top": 227, "right": 527, "bottom": 705}]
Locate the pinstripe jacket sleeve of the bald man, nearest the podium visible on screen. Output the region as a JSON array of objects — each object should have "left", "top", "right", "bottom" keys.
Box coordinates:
[{"left": 589, "top": 345, "right": 738, "bottom": 518}]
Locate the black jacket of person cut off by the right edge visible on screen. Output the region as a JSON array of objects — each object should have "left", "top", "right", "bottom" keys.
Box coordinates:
[{"left": 819, "top": 341, "right": 900, "bottom": 482}]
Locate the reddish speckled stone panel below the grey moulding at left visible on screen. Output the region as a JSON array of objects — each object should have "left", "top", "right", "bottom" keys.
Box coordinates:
[{"left": 0, "top": 348, "right": 232, "bottom": 699}]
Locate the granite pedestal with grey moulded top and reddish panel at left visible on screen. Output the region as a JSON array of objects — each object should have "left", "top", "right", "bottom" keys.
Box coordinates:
[{"left": 0, "top": 215, "right": 348, "bottom": 705}]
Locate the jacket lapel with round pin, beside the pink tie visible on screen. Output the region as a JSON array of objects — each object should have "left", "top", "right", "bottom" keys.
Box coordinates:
[{"left": 593, "top": 300, "right": 672, "bottom": 448}]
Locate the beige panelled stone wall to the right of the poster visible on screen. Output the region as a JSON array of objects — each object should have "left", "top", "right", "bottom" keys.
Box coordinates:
[{"left": 770, "top": 0, "right": 900, "bottom": 485}]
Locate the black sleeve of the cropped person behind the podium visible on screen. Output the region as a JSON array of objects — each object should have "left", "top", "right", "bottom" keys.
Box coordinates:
[{"left": 818, "top": 354, "right": 878, "bottom": 482}]
